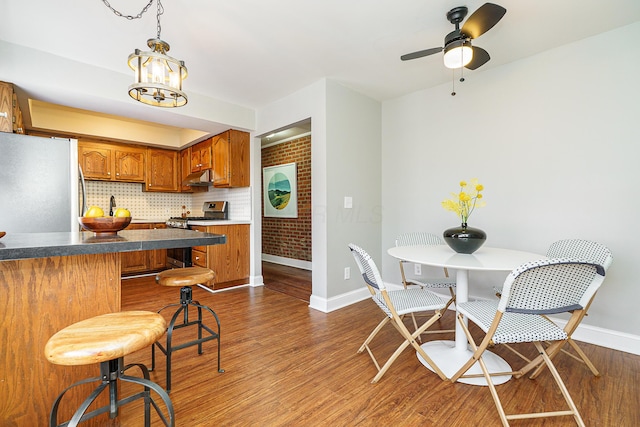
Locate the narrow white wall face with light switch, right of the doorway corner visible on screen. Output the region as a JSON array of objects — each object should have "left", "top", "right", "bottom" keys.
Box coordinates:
[{"left": 328, "top": 82, "right": 382, "bottom": 300}]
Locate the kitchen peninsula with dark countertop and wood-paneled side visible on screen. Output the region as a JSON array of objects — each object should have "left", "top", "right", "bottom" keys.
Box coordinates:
[{"left": 0, "top": 229, "right": 226, "bottom": 426}]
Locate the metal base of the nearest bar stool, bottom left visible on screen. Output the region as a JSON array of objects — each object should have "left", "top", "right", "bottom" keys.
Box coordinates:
[{"left": 49, "top": 357, "right": 175, "bottom": 427}]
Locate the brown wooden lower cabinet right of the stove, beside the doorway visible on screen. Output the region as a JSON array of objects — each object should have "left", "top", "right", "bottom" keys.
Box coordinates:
[{"left": 191, "top": 224, "right": 250, "bottom": 289}]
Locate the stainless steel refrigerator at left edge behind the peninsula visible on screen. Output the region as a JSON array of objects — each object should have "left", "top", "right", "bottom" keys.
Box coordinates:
[{"left": 0, "top": 132, "right": 84, "bottom": 233}]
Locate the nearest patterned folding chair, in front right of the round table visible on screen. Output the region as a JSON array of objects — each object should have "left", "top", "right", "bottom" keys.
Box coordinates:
[{"left": 451, "top": 258, "right": 605, "bottom": 426}]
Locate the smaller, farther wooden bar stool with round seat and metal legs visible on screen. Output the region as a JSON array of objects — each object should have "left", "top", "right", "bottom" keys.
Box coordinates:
[{"left": 151, "top": 267, "right": 224, "bottom": 392}]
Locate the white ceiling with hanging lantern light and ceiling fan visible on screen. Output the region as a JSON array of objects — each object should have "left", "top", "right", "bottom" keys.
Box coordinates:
[{"left": 0, "top": 0, "right": 640, "bottom": 142}]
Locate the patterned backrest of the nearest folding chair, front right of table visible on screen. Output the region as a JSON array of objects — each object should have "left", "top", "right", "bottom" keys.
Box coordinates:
[{"left": 498, "top": 258, "right": 605, "bottom": 314}]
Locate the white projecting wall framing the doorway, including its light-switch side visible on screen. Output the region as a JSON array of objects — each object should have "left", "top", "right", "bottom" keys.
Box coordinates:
[{"left": 252, "top": 80, "right": 381, "bottom": 311}]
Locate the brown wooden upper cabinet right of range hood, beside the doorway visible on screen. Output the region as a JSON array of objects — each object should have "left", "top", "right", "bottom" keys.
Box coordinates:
[{"left": 211, "top": 129, "right": 250, "bottom": 187}]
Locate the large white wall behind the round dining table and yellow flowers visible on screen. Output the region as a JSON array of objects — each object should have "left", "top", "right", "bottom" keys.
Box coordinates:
[{"left": 382, "top": 23, "right": 640, "bottom": 342}]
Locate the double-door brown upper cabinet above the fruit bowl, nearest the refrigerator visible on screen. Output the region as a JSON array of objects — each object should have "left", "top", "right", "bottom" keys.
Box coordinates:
[{"left": 78, "top": 140, "right": 145, "bottom": 182}]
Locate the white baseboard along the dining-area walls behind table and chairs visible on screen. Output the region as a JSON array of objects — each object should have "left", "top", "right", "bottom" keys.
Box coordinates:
[{"left": 316, "top": 283, "right": 640, "bottom": 355}]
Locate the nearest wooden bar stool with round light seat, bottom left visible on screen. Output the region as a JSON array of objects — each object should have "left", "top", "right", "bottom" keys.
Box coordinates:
[{"left": 44, "top": 311, "right": 175, "bottom": 427}]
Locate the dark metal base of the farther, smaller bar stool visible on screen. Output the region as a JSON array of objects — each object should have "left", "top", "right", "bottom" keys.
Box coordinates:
[{"left": 151, "top": 286, "right": 224, "bottom": 392}]
